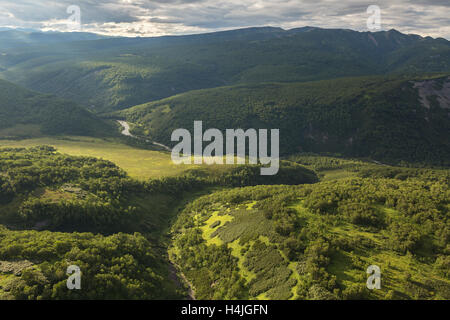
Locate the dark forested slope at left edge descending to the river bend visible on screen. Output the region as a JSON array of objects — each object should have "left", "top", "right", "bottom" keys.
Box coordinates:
[{"left": 0, "top": 80, "right": 114, "bottom": 138}]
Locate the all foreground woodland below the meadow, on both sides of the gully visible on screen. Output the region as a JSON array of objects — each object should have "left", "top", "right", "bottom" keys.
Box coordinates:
[{"left": 0, "top": 147, "right": 450, "bottom": 299}]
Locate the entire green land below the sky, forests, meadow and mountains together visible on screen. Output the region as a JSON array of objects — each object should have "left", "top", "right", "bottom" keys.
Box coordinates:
[{"left": 0, "top": 27, "right": 450, "bottom": 300}]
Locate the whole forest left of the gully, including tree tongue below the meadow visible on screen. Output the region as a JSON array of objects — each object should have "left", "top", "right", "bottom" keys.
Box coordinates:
[{"left": 0, "top": 146, "right": 318, "bottom": 299}]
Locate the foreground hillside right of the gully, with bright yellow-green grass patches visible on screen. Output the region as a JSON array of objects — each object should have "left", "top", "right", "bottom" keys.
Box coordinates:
[{"left": 170, "top": 156, "right": 450, "bottom": 300}]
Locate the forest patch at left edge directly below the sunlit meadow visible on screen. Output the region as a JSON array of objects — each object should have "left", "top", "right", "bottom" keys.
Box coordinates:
[{"left": 0, "top": 146, "right": 173, "bottom": 233}]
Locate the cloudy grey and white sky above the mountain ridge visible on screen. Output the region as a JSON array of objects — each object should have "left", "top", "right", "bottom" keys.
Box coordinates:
[{"left": 0, "top": 0, "right": 450, "bottom": 40}]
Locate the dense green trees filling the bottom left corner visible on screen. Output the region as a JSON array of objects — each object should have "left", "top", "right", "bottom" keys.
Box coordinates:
[{"left": 0, "top": 226, "right": 182, "bottom": 300}]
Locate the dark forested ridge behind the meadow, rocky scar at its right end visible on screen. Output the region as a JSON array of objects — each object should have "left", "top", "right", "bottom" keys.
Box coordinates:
[{"left": 116, "top": 75, "right": 450, "bottom": 164}]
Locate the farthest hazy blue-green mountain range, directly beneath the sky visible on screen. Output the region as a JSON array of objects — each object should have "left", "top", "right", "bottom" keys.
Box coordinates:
[{"left": 0, "top": 28, "right": 450, "bottom": 111}]
